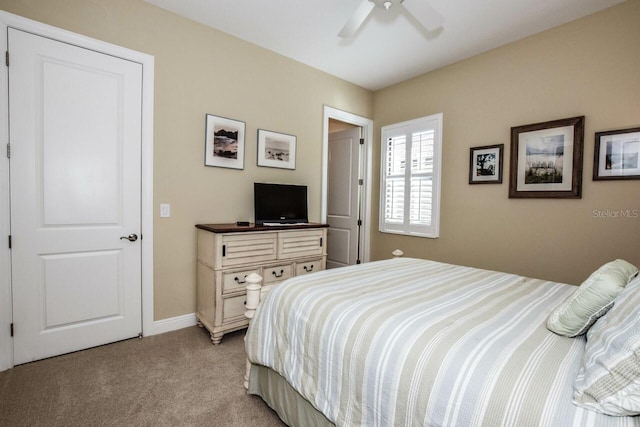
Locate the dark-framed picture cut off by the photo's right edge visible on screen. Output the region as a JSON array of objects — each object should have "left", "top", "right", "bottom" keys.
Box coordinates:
[{"left": 593, "top": 128, "right": 640, "bottom": 181}]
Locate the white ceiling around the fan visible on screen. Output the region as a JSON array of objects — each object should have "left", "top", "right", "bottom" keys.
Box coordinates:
[{"left": 145, "top": 0, "right": 624, "bottom": 90}]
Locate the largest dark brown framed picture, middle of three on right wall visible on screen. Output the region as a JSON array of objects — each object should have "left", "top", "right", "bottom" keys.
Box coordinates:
[{"left": 509, "top": 116, "right": 584, "bottom": 199}]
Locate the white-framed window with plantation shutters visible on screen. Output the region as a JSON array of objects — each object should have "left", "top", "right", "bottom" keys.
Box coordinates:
[{"left": 380, "top": 114, "right": 442, "bottom": 238}]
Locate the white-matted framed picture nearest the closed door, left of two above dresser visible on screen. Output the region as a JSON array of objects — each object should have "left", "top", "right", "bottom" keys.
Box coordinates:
[{"left": 204, "top": 114, "right": 245, "bottom": 169}]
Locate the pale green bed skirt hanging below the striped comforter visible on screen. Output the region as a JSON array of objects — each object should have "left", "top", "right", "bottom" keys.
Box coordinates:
[{"left": 249, "top": 365, "right": 334, "bottom": 427}]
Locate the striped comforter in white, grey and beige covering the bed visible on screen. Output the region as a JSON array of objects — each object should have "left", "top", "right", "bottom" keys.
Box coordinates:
[{"left": 246, "top": 258, "right": 640, "bottom": 427}]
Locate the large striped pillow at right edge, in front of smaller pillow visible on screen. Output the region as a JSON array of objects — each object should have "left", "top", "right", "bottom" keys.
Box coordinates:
[{"left": 573, "top": 277, "right": 640, "bottom": 416}]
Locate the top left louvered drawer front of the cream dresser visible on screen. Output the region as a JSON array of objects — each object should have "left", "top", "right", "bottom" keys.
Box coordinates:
[{"left": 220, "top": 233, "right": 278, "bottom": 267}]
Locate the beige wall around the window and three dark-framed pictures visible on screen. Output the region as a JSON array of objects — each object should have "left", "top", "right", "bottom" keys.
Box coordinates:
[{"left": 371, "top": 0, "right": 640, "bottom": 283}]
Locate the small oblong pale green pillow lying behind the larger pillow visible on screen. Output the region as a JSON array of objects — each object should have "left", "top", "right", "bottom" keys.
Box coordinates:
[{"left": 547, "top": 259, "right": 638, "bottom": 337}]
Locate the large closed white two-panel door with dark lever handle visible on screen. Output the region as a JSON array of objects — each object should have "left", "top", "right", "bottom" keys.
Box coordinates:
[{"left": 8, "top": 28, "right": 142, "bottom": 364}]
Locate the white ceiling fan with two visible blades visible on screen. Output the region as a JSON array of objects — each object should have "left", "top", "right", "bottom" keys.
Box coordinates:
[{"left": 338, "top": 0, "right": 444, "bottom": 39}]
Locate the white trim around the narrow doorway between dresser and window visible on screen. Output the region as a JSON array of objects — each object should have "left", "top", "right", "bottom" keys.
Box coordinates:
[{"left": 320, "top": 105, "right": 373, "bottom": 262}]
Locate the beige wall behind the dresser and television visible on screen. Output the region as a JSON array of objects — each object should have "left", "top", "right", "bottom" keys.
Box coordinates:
[{"left": 0, "top": 0, "right": 373, "bottom": 320}]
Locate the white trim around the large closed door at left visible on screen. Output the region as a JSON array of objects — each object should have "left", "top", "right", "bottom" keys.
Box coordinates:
[{"left": 0, "top": 11, "right": 154, "bottom": 371}]
